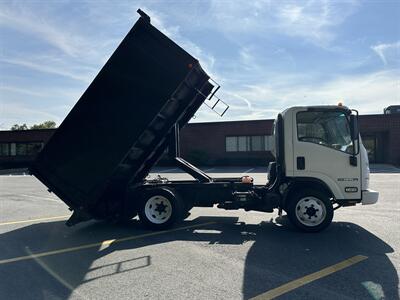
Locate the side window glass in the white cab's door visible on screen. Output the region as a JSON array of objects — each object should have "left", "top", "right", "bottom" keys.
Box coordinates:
[{"left": 297, "top": 111, "right": 353, "bottom": 153}]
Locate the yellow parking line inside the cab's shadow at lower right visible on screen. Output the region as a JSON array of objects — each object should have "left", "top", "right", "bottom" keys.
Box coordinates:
[{"left": 252, "top": 255, "right": 368, "bottom": 300}]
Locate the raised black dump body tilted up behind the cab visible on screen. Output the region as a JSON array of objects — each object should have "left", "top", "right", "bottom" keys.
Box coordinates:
[{"left": 31, "top": 13, "right": 214, "bottom": 218}]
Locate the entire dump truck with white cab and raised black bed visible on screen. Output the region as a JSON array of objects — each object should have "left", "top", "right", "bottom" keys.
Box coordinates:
[{"left": 30, "top": 10, "right": 378, "bottom": 232}]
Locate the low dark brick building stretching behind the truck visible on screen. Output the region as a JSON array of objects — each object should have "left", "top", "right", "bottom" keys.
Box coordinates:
[{"left": 0, "top": 114, "right": 400, "bottom": 169}]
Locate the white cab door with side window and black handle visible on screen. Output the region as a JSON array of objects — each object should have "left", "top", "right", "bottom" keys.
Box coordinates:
[{"left": 293, "top": 108, "right": 361, "bottom": 199}]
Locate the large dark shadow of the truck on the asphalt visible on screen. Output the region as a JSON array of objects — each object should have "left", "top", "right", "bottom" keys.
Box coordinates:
[{"left": 0, "top": 217, "right": 399, "bottom": 299}]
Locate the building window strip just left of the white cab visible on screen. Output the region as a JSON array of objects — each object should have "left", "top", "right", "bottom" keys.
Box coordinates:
[{"left": 225, "top": 135, "right": 273, "bottom": 152}]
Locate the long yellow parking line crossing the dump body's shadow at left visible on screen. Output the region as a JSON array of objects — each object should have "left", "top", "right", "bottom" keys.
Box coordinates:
[{"left": 0, "top": 222, "right": 215, "bottom": 265}]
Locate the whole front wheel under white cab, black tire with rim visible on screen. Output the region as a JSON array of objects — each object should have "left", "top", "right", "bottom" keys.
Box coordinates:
[{"left": 286, "top": 189, "right": 333, "bottom": 232}]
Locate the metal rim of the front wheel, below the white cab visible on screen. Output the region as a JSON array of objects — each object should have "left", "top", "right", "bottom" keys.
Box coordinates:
[{"left": 296, "top": 196, "right": 326, "bottom": 227}]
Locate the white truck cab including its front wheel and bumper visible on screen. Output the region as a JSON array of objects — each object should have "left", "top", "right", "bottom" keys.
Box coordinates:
[{"left": 271, "top": 105, "right": 379, "bottom": 231}]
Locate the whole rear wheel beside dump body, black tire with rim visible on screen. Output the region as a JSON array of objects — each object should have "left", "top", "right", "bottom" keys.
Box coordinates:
[{"left": 138, "top": 188, "right": 185, "bottom": 230}]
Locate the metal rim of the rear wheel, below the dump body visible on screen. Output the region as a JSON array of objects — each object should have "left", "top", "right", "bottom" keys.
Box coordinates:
[{"left": 144, "top": 195, "right": 172, "bottom": 224}]
